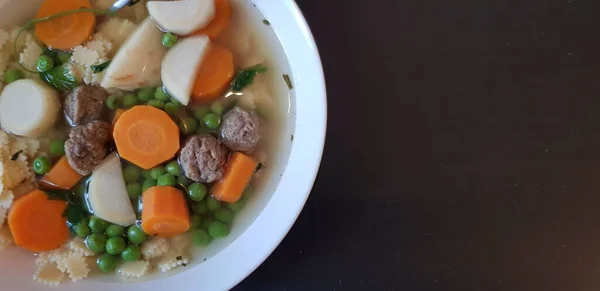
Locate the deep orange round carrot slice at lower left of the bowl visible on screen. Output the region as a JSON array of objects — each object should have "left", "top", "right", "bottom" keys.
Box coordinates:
[{"left": 8, "top": 190, "right": 69, "bottom": 252}]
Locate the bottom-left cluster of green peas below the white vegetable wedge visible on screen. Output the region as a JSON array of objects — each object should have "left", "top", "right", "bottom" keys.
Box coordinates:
[{"left": 74, "top": 215, "right": 146, "bottom": 272}]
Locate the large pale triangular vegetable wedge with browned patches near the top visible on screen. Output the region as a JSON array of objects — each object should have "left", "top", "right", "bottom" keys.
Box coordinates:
[{"left": 100, "top": 17, "right": 167, "bottom": 91}]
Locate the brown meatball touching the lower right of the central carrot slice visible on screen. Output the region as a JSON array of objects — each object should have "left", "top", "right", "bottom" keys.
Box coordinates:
[{"left": 179, "top": 135, "right": 227, "bottom": 183}]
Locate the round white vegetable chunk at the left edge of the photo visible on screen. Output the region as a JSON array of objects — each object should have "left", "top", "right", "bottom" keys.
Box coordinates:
[{"left": 0, "top": 80, "right": 60, "bottom": 138}]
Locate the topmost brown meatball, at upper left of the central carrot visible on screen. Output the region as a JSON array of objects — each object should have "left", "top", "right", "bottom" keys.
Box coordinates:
[{"left": 65, "top": 85, "right": 108, "bottom": 125}]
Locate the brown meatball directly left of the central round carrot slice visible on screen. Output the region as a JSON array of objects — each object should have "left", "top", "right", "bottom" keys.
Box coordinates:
[{"left": 65, "top": 121, "right": 110, "bottom": 176}]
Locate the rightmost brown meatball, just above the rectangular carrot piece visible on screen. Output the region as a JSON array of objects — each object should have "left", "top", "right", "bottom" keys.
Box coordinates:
[{"left": 220, "top": 107, "right": 260, "bottom": 153}]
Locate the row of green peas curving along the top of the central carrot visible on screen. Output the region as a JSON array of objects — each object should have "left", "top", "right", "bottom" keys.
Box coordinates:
[{"left": 106, "top": 87, "right": 224, "bottom": 135}]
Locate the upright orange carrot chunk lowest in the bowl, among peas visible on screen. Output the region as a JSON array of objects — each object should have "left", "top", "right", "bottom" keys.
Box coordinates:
[{"left": 142, "top": 186, "right": 191, "bottom": 237}]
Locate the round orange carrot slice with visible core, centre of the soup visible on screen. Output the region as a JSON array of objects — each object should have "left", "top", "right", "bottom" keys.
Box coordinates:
[{"left": 113, "top": 105, "right": 179, "bottom": 170}]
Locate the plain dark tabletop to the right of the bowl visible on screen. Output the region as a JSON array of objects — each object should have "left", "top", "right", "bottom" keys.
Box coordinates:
[{"left": 235, "top": 0, "right": 600, "bottom": 291}]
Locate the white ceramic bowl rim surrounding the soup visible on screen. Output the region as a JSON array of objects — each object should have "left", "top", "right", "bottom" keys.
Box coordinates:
[{"left": 0, "top": 0, "right": 327, "bottom": 291}]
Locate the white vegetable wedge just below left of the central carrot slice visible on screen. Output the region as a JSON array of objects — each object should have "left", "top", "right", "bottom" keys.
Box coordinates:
[{"left": 88, "top": 153, "right": 135, "bottom": 226}]
